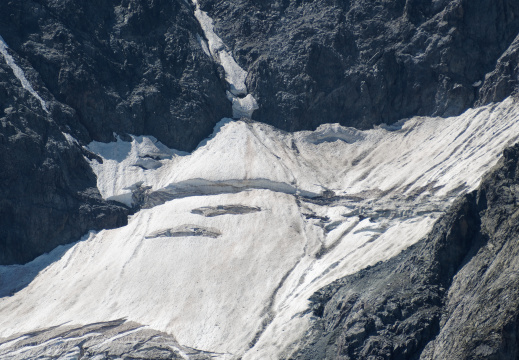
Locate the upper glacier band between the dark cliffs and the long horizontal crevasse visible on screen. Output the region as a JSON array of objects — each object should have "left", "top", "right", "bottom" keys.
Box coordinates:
[{"left": 88, "top": 99, "right": 519, "bottom": 208}]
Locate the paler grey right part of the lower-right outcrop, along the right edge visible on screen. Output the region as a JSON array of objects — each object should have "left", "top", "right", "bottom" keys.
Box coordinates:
[{"left": 421, "top": 145, "right": 519, "bottom": 360}]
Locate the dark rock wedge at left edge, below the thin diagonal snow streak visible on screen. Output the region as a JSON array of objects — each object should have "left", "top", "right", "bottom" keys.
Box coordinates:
[{"left": 0, "top": 54, "right": 128, "bottom": 264}]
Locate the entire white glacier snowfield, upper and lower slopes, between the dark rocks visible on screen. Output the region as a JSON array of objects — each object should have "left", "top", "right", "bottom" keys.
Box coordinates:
[{"left": 0, "top": 99, "right": 519, "bottom": 359}]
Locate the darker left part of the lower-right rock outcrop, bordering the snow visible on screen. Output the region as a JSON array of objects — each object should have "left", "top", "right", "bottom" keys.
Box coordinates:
[{"left": 292, "top": 194, "right": 479, "bottom": 360}]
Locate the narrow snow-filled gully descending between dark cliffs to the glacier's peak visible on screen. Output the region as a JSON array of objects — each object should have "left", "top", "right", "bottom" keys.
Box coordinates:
[{"left": 192, "top": 0, "right": 258, "bottom": 119}]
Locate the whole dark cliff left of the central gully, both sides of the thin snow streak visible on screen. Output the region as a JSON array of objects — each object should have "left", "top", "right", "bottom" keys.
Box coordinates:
[{"left": 0, "top": 0, "right": 231, "bottom": 264}]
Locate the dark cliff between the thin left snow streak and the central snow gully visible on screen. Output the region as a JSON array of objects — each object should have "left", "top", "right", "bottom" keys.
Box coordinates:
[{"left": 0, "top": 0, "right": 232, "bottom": 150}]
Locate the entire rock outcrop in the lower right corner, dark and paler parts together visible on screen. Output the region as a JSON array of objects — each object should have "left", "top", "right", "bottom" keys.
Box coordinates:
[{"left": 293, "top": 145, "right": 519, "bottom": 359}]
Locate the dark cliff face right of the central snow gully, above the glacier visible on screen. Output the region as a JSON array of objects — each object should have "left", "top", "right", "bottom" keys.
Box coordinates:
[{"left": 200, "top": 0, "right": 519, "bottom": 130}]
